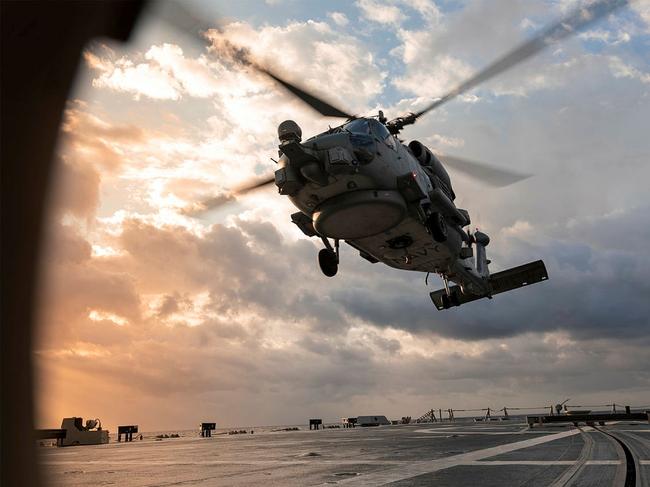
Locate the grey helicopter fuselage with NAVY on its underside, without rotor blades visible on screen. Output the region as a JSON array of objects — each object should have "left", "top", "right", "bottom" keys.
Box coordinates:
[{"left": 276, "top": 119, "right": 489, "bottom": 295}]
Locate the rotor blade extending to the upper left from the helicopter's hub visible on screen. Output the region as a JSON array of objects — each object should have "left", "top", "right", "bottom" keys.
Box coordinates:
[{"left": 151, "top": 2, "right": 354, "bottom": 119}]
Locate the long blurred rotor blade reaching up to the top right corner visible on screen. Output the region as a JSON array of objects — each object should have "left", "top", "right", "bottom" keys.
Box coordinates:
[{"left": 414, "top": 0, "right": 629, "bottom": 118}]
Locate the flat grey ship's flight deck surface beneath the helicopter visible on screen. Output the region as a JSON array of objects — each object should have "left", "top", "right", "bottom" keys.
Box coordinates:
[{"left": 40, "top": 421, "right": 650, "bottom": 487}]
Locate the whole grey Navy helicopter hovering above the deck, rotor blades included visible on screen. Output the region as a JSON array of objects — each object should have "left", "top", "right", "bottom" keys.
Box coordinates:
[{"left": 186, "top": 0, "right": 627, "bottom": 310}]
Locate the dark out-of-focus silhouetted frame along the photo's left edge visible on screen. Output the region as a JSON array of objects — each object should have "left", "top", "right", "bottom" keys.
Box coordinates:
[{"left": 0, "top": 0, "right": 144, "bottom": 486}]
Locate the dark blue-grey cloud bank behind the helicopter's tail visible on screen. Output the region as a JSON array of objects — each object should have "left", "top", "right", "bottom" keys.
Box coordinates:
[{"left": 332, "top": 209, "right": 650, "bottom": 340}]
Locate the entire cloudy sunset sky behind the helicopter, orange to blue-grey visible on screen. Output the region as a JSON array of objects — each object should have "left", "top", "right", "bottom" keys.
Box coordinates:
[{"left": 34, "top": 0, "right": 650, "bottom": 431}]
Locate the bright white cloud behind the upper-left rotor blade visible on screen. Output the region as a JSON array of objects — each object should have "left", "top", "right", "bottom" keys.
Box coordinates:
[{"left": 84, "top": 19, "right": 385, "bottom": 114}]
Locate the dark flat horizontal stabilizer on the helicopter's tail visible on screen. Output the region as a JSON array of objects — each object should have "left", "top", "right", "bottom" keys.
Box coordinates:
[{"left": 429, "top": 260, "right": 548, "bottom": 309}]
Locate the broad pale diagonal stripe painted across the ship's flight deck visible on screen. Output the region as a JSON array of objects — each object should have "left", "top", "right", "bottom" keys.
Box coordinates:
[{"left": 338, "top": 428, "right": 580, "bottom": 486}]
